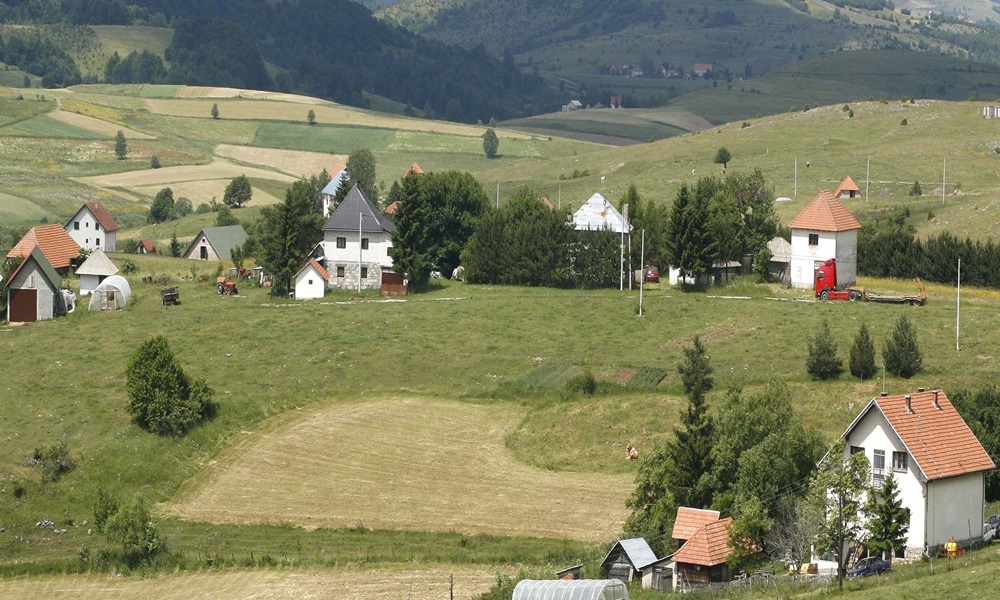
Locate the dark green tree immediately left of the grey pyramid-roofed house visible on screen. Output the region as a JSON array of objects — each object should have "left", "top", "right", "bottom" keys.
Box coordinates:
[{"left": 255, "top": 180, "right": 323, "bottom": 293}]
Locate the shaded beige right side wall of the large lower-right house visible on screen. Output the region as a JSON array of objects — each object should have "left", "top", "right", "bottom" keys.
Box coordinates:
[{"left": 924, "top": 473, "right": 985, "bottom": 550}]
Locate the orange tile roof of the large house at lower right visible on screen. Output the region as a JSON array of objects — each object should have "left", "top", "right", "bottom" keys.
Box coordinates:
[{"left": 868, "top": 391, "right": 996, "bottom": 481}]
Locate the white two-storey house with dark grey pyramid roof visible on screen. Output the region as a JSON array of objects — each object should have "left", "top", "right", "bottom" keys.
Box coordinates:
[{"left": 321, "top": 185, "right": 396, "bottom": 290}]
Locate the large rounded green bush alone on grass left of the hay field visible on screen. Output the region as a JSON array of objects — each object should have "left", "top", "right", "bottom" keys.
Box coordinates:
[{"left": 125, "top": 335, "right": 216, "bottom": 436}]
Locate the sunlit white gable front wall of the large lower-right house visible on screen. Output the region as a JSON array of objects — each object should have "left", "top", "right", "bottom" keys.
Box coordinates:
[{"left": 844, "top": 407, "right": 928, "bottom": 556}]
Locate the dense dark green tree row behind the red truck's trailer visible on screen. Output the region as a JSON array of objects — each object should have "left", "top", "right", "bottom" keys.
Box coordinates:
[{"left": 858, "top": 218, "right": 1000, "bottom": 288}]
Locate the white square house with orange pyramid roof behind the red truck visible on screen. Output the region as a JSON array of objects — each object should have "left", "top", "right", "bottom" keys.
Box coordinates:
[{"left": 790, "top": 190, "right": 861, "bottom": 288}]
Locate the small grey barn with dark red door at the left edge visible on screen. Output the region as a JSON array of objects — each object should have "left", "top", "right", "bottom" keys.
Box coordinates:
[{"left": 5, "top": 245, "right": 64, "bottom": 323}]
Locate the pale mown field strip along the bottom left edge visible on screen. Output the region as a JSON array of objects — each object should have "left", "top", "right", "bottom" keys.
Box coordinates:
[{"left": 0, "top": 566, "right": 496, "bottom": 600}]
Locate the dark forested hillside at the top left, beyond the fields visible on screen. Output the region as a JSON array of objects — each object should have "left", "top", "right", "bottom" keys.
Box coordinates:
[{"left": 0, "top": 0, "right": 562, "bottom": 122}]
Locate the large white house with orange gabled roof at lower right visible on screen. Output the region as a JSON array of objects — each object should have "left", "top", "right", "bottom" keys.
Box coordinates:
[{"left": 841, "top": 388, "right": 996, "bottom": 557}]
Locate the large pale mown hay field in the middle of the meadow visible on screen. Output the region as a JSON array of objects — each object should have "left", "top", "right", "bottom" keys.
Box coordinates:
[{"left": 165, "top": 398, "right": 632, "bottom": 541}]
